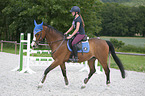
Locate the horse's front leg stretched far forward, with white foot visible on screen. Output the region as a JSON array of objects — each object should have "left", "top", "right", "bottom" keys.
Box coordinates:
[{"left": 38, "top": 61, "right": 60, "bottom": 88}]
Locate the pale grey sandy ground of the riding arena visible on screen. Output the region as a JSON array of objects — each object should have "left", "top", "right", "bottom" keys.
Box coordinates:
[{"left": 0, "top": 52, "right": 145, "bottom": 96}]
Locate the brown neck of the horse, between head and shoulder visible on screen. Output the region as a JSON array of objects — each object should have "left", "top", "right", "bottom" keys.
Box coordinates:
[{"left": 46, "top": 28, "right": 64, "bottom": 51}]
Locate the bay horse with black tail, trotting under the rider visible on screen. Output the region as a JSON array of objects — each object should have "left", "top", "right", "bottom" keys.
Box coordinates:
[{"left": 31, "top": 21, "right": 125, "bottom": 88}]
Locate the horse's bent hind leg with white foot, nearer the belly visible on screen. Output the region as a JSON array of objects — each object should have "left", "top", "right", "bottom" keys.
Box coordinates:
[{"left": 81, "top": 58, "right": 96, "bottom": 88}]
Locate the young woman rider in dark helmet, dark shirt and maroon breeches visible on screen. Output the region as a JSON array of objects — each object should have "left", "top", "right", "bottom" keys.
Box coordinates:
[{"left": 65, "top": 6, "right": 85, "bottom": 62}]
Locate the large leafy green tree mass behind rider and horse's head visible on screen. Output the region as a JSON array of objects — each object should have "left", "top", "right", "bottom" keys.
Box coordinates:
[{"left": 0, "top": 0, "right": 101, "bottom": 41}]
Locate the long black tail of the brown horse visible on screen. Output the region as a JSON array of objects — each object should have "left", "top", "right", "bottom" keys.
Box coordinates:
[{"left": 106, "top": 41, "right": 125, "bottom": 78}]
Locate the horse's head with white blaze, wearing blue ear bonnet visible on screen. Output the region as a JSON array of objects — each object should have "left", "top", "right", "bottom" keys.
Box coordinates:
[{"left": 31, "top": 20, "right": 45, "bottom": 47}]
